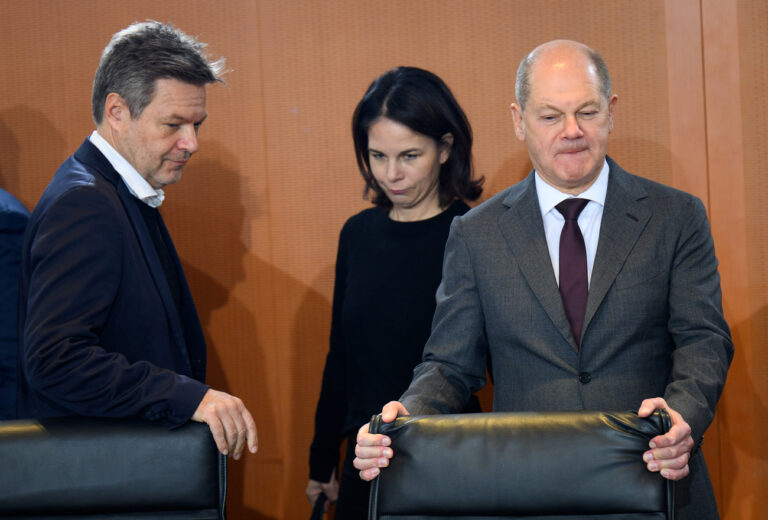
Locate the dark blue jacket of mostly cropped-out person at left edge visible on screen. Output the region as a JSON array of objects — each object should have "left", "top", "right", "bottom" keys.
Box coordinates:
[{"left": 0, "top": 188, "right": 29, "bottom": 420}]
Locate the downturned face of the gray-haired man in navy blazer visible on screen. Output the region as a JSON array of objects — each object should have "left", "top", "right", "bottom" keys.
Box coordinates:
[{"left": 113, "top": 79, "right": 206, "bottom": 189}]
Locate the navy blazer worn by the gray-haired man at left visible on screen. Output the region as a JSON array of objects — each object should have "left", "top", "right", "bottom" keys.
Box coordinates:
[{"left": 17, "top": 139, "right": 208, "bottom": 427}]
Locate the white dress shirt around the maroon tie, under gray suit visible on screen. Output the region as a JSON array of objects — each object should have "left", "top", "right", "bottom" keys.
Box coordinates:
[{"left": 536, "top": 161, "right": 608, "bottom": 285}]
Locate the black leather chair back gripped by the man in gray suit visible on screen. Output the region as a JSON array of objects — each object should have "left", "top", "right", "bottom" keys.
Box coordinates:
[{"left": 369, "top": 411, "right": 674, "bottom": 520}]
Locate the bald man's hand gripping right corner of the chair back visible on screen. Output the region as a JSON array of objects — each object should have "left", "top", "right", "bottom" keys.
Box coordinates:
[{"left": 637, "top": 397, "right": 694, "bottom": 480}]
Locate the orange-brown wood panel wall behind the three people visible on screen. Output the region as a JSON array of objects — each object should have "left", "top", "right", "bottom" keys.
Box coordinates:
[{"left": 0, "top": 0, "right": 768, "bottom": 520}]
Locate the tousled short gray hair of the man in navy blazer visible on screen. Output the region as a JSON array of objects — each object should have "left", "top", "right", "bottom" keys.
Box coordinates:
[{"left": 91, "top": 21, "right": 224, "bottom": 125}]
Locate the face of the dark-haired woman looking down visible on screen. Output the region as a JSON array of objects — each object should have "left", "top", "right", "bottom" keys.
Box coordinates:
[{"left": 368, "top": 117, "right": 453, "bottom": 220}]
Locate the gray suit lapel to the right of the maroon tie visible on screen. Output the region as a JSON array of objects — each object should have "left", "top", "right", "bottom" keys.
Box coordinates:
[{"left": 582, "top": 157, "right": 651, "bottom": 334}]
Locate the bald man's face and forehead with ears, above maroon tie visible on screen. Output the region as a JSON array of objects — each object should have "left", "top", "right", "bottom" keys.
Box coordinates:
[{"left": 511, "top": 47, "right": 617, "bottom": 195}]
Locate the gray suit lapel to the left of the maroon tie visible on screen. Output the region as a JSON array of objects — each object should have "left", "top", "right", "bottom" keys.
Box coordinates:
[{"left": 499, "top": 172, "right": 578, "bottom": 350}]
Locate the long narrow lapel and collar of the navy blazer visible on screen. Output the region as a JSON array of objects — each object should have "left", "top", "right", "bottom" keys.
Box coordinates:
[{"left": 76, "top": 139, "right": 191, "bottom": 368}]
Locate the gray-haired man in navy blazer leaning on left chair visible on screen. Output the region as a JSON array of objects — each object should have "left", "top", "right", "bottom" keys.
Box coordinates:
[{"left": 18, "top": 22, "right": 257, "bottom": 459}]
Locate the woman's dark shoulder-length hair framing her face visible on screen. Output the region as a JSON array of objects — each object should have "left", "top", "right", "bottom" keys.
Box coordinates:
[{"left": 352, "top": 67, "right": 483, "bottom": 209}]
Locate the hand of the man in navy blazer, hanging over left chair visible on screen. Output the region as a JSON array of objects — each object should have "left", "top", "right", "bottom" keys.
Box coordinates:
[{"left": 192, "top": 388, "right": 259, "bottom": 460}]
